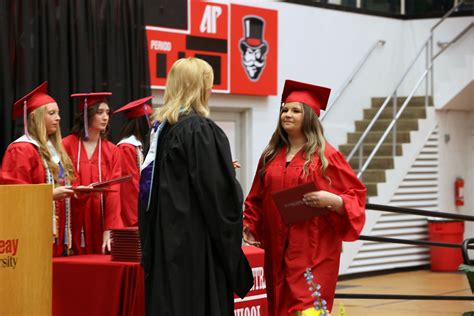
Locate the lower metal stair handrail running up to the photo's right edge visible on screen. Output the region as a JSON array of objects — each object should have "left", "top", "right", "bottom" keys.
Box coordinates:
[{"left": 354, "top": 23, "right": 474, "bottom": 178}]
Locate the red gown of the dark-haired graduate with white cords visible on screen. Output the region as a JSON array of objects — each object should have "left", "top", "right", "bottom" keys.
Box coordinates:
[{"left": 63, "top": 135, "right": 123, "bottom": 254}]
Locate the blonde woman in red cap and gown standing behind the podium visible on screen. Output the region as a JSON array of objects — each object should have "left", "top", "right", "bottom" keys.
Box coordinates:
[{"left": 0, "top": 82, "right": 78, "bottom": 257}]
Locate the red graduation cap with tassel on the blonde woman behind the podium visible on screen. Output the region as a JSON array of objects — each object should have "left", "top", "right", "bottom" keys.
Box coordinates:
[{"left": 13, "top": 81, "right": 56, "bottom": 137}]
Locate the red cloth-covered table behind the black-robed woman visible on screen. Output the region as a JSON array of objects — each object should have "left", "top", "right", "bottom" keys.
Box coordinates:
[{"left": 53, "top": 246, "right": 268, "bottom": 316}]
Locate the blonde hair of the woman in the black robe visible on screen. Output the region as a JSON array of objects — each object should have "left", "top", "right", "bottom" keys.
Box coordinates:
[{"left": 154, "top": 57, "right": 214, "bottom": 124}]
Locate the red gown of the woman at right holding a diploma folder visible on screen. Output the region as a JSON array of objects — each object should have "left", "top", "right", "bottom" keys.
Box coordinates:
[{"left": 244, "top": 143, "right": 366, "bottom": 316}]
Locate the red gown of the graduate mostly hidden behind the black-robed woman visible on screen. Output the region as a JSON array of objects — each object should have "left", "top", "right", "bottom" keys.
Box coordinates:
[{"left": 117, "top": 142, "right": 141, "bottom": 226}]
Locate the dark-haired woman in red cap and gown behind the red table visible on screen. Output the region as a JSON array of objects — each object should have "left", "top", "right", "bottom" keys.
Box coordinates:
[{"left": 63, "top": 92, "right": 123, "bottom": 254}]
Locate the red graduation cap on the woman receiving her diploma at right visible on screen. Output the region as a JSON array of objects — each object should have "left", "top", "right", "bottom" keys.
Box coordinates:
[{"left": 281, "top": 80, "right": 331, "bottom": 116}]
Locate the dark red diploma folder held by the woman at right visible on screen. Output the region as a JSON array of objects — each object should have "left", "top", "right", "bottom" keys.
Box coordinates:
[{"left": 272, "top": 182, "right": 329, "bottom": 224}]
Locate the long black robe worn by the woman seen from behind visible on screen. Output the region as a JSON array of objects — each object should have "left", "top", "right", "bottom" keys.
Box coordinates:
[{"left": 139, "top": 113, "right": 253, "bottom": 316}]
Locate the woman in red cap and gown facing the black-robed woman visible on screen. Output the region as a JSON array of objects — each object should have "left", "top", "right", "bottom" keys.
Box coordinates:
[{"left": 244, "top": 80, "right": 366, "bottom": 316}]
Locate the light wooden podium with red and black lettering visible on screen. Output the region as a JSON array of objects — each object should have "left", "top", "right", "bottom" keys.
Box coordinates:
[{"left": 0, "top": 184, "right": 53, "bottom": 316}]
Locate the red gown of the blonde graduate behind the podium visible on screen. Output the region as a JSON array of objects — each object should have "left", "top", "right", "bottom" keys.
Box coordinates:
[{"left": 2, "top": 142, "right": 70, "bottom": 257}]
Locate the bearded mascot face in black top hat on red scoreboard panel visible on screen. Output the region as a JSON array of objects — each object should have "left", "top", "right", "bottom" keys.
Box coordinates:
[{"left": 240, "top": 16, "right": 268, "bottom": 81}]
